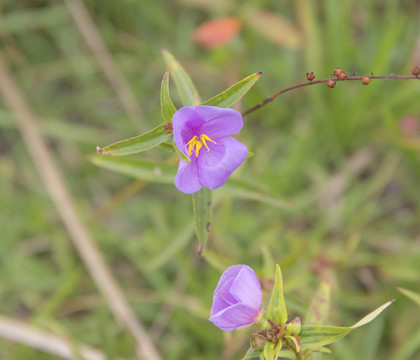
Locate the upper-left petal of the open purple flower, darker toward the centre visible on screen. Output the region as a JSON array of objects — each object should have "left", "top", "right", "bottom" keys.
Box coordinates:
[{"left": 172, "top": 106, "right": 205, "bottom": 154}]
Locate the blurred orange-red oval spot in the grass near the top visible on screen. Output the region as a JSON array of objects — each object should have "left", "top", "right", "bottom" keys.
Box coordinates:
[{"left": 194, "top": 17, "right": 242, "bottom": 49}]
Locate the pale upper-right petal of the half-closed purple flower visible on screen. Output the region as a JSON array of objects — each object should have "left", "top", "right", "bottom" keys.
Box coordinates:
[{"left": 230, "top": 266, "right": 262, "bottom": 311}]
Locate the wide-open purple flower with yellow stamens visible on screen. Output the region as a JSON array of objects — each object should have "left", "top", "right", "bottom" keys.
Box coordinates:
[{"left": 172, "top": 105, "right": 248, "bottom": 194}]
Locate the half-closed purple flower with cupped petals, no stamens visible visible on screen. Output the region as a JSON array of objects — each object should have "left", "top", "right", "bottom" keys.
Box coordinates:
[{"left": 209, "top": 265, "right": 262, "bottom": 331}]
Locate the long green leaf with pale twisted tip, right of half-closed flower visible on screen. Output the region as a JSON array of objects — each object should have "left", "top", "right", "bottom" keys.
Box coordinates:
[{"left": 300, "top": 300, "right": 394, "bottom": 351}]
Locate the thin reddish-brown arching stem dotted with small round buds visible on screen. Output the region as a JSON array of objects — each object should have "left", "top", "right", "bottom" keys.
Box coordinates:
[{"left": 242, "top": 74, "right": 420, "bottom": 116}]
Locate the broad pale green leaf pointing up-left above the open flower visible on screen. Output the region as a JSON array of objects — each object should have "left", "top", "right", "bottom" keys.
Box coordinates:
[{"left": 162, "top": 49, "right": 200, "bottom": 106}]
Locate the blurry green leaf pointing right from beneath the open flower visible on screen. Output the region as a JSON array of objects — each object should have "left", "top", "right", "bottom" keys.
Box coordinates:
[{"left": 222, "top": 178, "right": 290, "bottom": 209}]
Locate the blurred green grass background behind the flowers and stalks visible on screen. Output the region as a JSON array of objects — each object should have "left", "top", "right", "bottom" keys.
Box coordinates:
[{"left": 0, "top": 0, "right": 420, "bottom": 360}]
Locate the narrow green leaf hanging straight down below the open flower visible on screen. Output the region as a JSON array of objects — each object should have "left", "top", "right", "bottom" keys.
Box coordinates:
[{"left": 192, "top": 186, "right": 212, "bottom": 253}]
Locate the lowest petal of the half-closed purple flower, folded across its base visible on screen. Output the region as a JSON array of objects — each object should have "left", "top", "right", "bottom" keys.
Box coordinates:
[{"left": 209, "top": 304, "right": 258, "bottom": 331}]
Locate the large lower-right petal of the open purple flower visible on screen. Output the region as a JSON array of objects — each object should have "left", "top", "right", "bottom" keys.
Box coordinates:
[{"left": 198, "top": 137, "right": 248, "bottom": 190}]
